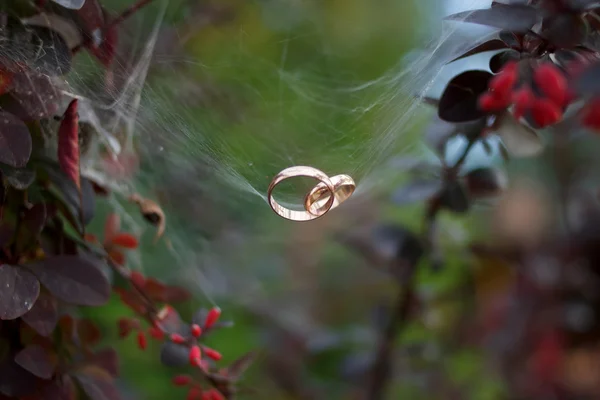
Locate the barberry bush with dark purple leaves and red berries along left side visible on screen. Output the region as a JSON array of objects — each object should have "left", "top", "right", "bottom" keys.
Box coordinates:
[{"left": 0, "top": 0, "right": 252, "bottom": 400}]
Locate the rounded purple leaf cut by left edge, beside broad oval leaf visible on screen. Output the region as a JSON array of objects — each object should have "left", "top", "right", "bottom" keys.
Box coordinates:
[{"left": 0, "top": 264, "right": 40, "bottom": 319}]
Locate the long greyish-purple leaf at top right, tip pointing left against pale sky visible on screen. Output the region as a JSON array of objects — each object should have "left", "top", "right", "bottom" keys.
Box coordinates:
[{"left": 445, "top": 4, "right": 540, "bottom": 33}]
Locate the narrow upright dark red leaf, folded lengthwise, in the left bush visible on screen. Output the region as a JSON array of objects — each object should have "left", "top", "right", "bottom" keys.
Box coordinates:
[{"left": 58, "top": 99, "right": 81, "bottom": 188}]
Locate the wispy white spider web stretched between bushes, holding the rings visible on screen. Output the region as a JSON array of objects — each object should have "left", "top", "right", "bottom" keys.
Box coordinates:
[{"left": 36, "top": 1, "right": 492, "bottom": 301}]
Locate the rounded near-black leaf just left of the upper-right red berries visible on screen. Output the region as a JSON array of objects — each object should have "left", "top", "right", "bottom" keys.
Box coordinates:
[{"left": 438, "top": 71, "right": 492, "bottom": 122}]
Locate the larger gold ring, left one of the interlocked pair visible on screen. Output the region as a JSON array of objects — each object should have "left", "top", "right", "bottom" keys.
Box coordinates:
[{"left": 267, "top": 166, "right": 336, "bottom": 221}]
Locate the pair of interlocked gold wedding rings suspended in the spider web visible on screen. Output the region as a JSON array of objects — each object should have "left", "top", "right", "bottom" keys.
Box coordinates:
[{"left": 267, "top": 166, "right": 356, "bottom": 221}]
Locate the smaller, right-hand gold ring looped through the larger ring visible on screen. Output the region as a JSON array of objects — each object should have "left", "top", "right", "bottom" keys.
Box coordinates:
[{"left": 304, "top": 174, "right": 356, "bottom": 215}]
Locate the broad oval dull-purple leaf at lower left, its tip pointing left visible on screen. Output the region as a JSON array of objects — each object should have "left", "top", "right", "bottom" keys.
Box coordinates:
[{"left": 26, "top": 255, "right": 110, "bottom": 306}]
